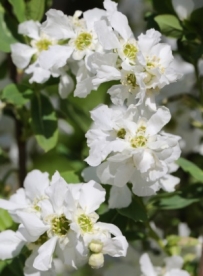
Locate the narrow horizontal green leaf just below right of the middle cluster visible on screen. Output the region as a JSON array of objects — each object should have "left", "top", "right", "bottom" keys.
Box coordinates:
[{"left": 157, "top": 195, "right": 200, "bottom": 210}]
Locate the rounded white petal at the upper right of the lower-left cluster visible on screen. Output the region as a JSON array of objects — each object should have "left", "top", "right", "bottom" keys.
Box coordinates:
[{"left": 79, "top": 181, "right": 106, "bottom": 213}]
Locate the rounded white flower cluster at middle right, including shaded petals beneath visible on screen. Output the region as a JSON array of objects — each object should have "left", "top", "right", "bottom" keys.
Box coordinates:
[{"left": 86, "top": 105, "right": 180, "bottom": 208}]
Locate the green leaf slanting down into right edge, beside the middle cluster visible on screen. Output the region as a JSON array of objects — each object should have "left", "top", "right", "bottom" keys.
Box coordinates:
[{"left": 176, "top": 157, "right": 203, "bottom": 183}]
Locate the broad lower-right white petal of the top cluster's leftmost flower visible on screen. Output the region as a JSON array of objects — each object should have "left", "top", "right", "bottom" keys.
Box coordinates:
[{"left": 39, "top": 45, "right": 73, "bottom": 70}]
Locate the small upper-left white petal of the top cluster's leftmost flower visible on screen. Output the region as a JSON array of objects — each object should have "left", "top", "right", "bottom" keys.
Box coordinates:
[{"left": 18, "top": 20, "right": 41, "bottom": 39}]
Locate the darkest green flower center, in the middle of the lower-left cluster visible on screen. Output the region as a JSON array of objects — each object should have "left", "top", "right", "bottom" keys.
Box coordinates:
[{"left": 52, "top": 215, "right": 70, "bottom": 236}]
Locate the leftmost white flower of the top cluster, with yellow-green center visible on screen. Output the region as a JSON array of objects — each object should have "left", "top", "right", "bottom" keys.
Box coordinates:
[{"left": 11, "top": 20, "right": 73, "bottom": 98}]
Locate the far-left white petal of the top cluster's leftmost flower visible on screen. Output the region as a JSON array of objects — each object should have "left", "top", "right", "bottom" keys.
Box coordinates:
[{"left": 11, "top": 43, "right": 36, "bottom": 69}]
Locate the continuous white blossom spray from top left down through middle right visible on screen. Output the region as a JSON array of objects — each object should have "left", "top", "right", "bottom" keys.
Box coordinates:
[{"left": 9, "top": 0, "right": 180, "bottom": 208}]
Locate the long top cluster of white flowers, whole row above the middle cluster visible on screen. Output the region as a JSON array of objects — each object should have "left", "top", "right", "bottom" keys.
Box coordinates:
[{"left": 11, "top": 0, "right": 180, "bottom": 106}]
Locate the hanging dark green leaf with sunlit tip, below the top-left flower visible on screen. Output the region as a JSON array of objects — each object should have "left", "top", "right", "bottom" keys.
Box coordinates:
[{"left": 31, "top": 94, "right": 58, "bottom": 152}]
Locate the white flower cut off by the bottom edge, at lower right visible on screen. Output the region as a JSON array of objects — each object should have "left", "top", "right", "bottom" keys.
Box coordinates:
[{"left": 140, "top": 253, "right": 189, "bottom": 276}]
